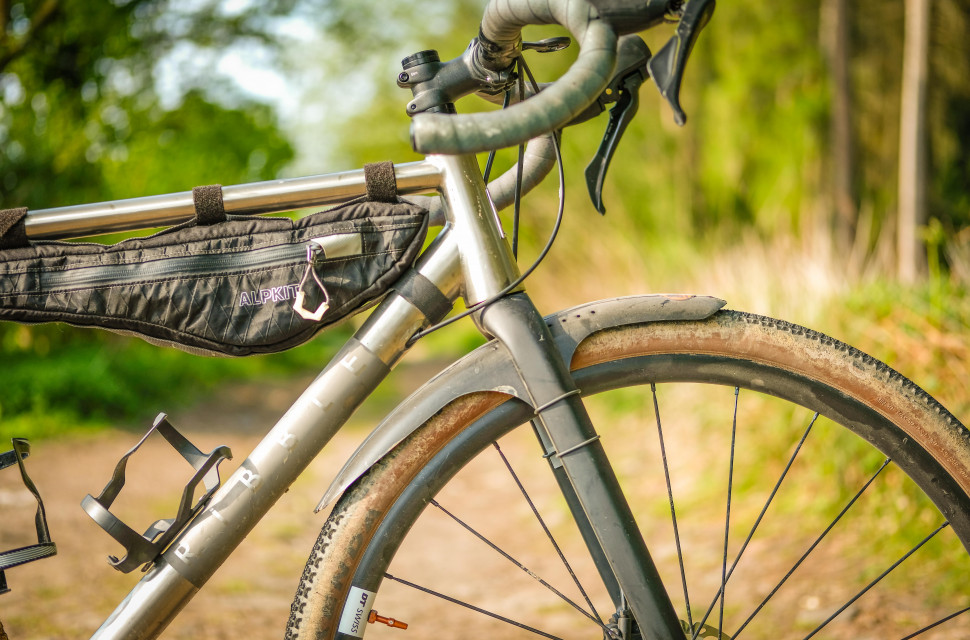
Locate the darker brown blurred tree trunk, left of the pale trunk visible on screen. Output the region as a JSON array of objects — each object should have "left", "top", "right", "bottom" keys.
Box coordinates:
[{"left": 819, "top": 0, "right": 858, "bottom": 255}]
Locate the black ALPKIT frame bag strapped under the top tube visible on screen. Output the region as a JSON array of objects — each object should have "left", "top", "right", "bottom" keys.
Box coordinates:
[{"left": 0, "top": 185, "right": 428, "bottom": 356}]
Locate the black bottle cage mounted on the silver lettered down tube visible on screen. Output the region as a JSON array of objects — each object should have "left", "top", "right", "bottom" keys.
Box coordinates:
[{"left": 81, "top": 413, "right": 232, "bottom": 573}]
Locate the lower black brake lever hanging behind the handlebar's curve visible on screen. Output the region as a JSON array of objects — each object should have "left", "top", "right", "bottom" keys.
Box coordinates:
[{"left": 574, "top": 35, "right": 650, "bottom": 214}]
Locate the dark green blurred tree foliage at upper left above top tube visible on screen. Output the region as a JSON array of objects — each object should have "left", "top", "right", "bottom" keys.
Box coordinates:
[{"left": 0, "top": 0, "right": 293, "bottom": 208}]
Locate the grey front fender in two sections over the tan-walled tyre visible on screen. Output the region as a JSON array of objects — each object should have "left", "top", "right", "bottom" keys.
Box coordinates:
[{"left": 315, "top": 295, "right": 725, "bottom": 511}]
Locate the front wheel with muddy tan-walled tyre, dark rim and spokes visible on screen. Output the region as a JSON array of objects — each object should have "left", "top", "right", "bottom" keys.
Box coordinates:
[{"left": 287, "top": 311, "right": 970, "bottom": 640}]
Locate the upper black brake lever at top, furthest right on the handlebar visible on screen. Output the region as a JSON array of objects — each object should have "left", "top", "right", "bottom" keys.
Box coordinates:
[{"left": 647, "top": 0, "right": 715, "bottom": 126}]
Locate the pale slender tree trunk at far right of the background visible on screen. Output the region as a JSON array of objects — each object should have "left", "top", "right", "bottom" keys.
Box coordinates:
[{"left": 896, "top": 0, "right": 930, "bottom": 283}]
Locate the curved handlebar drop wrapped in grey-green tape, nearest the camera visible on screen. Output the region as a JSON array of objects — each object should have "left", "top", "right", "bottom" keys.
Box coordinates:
[{"left": 411, "top": 0, "right": 617, "bottom": 154}]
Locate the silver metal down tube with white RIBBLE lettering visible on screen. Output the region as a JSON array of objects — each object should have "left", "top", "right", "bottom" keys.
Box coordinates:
[{"left": 86, "top": 168, "right": 460, "bottom": 640}]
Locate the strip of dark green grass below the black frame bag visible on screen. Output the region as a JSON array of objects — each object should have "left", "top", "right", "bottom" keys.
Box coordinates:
[{"left": 0, "top": 325, "right": 346, "bottom": 439}]
